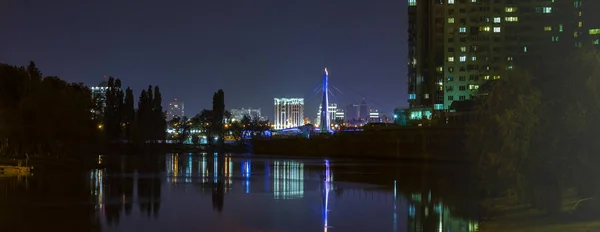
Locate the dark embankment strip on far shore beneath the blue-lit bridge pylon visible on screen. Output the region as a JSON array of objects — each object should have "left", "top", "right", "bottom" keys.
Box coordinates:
[{"left": 252, "top": 127, "right": 468, "bottom": 161}]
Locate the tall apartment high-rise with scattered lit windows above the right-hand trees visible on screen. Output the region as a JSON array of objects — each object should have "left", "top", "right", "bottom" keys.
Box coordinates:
[{"left": 408, "top": 0, "right": 584, "bottom": 120}]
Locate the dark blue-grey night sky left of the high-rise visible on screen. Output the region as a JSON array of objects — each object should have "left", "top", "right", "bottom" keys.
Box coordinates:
[{"left": 0, "top": 0, "right": 407, "bottom": 118}]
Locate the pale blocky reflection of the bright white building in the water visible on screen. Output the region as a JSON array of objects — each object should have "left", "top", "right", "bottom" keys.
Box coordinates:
[{"left": 273, "top": 161, "right": 304, "bottom": 200}]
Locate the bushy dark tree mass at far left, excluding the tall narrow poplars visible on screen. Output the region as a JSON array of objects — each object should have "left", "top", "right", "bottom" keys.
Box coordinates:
[{"left": 0, "top": 62, "right": 99, "bottom": 156}]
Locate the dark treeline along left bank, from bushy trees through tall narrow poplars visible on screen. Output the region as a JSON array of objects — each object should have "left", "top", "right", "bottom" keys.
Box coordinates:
[{"left": 0, "top": 62, "right": 166, "bottom": 157}]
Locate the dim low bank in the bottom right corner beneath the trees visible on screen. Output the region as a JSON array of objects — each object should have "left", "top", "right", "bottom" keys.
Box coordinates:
[{"left": 479, "top": 198, "right": 600, "bottom": 232}]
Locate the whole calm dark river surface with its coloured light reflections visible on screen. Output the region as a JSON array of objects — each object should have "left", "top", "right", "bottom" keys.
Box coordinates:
[{"left": 0, "top": 154, "right": 478, "bottom": 232}]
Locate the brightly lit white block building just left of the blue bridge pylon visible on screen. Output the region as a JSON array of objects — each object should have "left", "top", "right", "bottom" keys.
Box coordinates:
[{"left": 273, "top": 98, "right": 304, "bottom": 130}]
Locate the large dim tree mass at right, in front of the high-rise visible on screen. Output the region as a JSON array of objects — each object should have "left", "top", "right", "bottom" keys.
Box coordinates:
[{"left": 468, "top": 44, "right": 600, "bottom": 213}]
